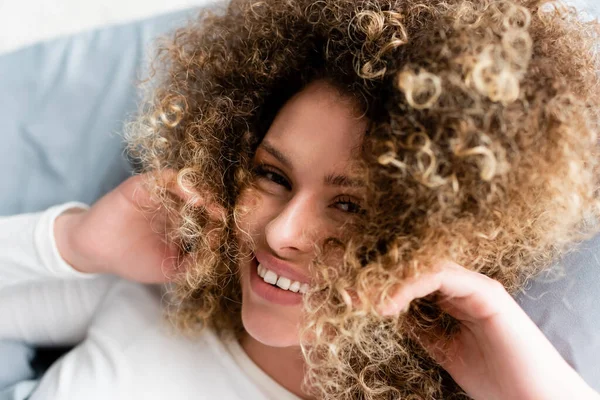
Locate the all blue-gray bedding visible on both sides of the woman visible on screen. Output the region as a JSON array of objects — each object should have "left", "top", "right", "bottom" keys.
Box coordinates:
[{"left": 0, "top": 3, "right": 600, "bottom": 400}]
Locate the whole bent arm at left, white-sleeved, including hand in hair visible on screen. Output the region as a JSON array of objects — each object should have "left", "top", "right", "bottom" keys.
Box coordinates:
[{"left": 0, "top": 171, "right": 204, "bottom": 344}]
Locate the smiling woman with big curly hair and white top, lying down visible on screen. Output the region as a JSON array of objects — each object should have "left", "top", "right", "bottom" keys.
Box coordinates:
[{"left": 2, "top": 1, "right": 599, "bottom": 399}]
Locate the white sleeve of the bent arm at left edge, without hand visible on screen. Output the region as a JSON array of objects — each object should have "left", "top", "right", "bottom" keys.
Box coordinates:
[{"left": 0, "top": 202, "right": 118, "bottom": 345}]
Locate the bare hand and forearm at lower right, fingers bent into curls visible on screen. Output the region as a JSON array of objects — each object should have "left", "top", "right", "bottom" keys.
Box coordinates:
[{"left": 380, "top": 262, "right": 600, "bottom": 400}]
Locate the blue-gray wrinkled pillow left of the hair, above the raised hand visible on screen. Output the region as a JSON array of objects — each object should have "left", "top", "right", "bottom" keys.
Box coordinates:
[{"left": 0, "top": 10, "right": 195, "bottom": 215}]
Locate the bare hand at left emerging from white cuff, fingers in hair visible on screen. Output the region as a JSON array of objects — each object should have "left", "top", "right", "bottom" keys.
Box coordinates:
[{"left": 54, "top": 170, "right": 222, "bottom": 283}]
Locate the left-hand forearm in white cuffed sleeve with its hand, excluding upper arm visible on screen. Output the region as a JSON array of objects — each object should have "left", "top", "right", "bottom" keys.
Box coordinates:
[{"left": 0, "top": 170, "right": 186, "bottom": 288}]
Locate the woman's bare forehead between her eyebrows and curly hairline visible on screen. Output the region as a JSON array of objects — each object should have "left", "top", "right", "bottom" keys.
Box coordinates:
[{"left": 264, "top": 82, "right": 367, "bottom": 169}]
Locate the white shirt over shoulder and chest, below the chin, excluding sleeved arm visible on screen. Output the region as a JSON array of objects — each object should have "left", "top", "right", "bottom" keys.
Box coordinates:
[{"left": 32, "top": 281, "right": 264, "bottom": 400}]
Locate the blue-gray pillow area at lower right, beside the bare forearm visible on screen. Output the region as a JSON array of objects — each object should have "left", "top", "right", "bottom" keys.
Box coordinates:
[{"left": 516, "top": 235, "right": 600, "bottom": 392}]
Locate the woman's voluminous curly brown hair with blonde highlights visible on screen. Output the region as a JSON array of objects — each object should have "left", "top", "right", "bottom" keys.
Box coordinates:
[{"left": 127, "top": 0, "right": 600, "bottom": 399}]
